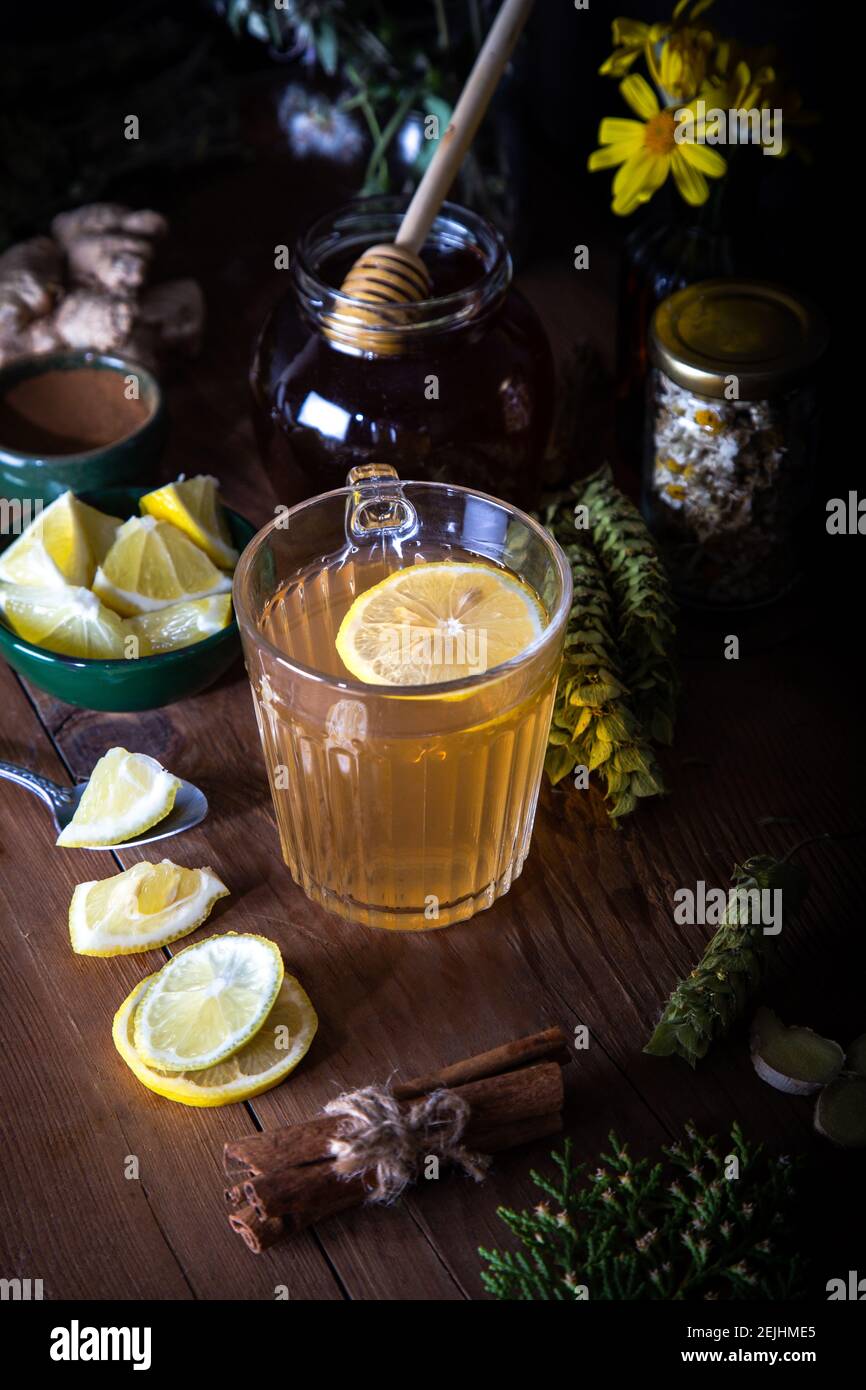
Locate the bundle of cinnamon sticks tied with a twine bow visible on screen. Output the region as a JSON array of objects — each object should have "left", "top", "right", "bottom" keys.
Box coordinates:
[{"left": 224, "top": 1029, "right": 569, "bottom": 1254}]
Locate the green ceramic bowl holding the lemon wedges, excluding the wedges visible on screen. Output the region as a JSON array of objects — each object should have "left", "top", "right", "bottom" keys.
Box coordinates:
[{"left": 0, "top": 488, "right": 256, "bottom": 713}]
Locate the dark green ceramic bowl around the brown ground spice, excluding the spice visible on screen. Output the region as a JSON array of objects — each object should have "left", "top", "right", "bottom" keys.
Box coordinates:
[{"left": 0, "top": 352, "right": 167, "bottom": 507}]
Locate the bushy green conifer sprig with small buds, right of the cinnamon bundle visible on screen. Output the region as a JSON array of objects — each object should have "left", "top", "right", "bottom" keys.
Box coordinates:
[{"left": 478, "top": 1125, "right": 805, "bottom": 1302}]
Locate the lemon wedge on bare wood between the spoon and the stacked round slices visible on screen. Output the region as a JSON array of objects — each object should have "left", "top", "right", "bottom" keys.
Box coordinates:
[{"left": 70, "top": 859, "right": 228, "bottom": 956}]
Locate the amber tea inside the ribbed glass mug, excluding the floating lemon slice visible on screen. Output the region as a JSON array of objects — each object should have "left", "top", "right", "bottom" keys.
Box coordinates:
[{"left": 254, "top": 545, "right": 559, "bottom": 930}]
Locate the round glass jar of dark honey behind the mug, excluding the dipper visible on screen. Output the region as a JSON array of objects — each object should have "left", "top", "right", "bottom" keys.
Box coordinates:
[{"left": 250, "top": 197, "right": 553, "bottom": 509}]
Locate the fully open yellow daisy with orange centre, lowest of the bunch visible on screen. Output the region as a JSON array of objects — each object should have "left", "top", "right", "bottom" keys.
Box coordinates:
[{"left": 587, "top": 72, "right": 727, "bottom": 217}]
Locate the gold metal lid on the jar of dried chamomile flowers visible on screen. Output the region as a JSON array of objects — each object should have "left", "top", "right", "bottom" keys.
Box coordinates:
[{"left": 649, "top": 279, "right": 827, "bottom": 400}]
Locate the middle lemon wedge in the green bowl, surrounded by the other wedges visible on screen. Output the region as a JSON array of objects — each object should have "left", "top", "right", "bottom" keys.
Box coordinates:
[{"left": 93, "top": 517, "right": 232, "bottom": 617}]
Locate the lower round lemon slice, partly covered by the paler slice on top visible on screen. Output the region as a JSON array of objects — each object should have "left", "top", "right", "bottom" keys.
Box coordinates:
[{"left": 111, "top": 974, "right": 318, "bottom": 1105}]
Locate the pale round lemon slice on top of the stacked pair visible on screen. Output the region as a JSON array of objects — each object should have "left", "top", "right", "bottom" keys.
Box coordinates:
[{"left": 135, "top": 931, "right": 284, "bottom": 1072}]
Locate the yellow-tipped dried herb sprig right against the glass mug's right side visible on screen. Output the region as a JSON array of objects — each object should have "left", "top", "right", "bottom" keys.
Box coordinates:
[{"left": 545, "top": 503, "right": 664, "bottom": 820}]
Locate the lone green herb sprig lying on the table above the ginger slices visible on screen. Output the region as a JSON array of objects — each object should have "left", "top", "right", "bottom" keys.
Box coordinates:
[{"left": 644, "top": 855, "right": 809, "bottom": 1066}]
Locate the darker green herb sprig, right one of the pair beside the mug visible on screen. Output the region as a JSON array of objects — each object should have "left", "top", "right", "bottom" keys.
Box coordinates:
[{"left": 578, "top": 466, "right": 678, "bottom": 744}]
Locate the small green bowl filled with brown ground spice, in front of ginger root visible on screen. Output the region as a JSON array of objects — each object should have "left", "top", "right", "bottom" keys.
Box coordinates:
[{"left": 0, "top": 352, "right": 165, "bottom": 506}]
